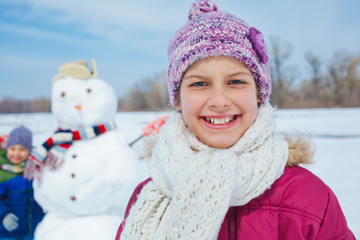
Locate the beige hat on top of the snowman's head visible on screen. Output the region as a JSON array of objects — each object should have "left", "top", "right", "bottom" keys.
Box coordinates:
[{"left": 52, "top": 59, "right": 97, "bottom": 83}]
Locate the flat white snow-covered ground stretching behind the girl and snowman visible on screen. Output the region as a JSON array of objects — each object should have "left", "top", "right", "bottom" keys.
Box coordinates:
[{"left": 0, "top": 108, "right": 360, "bottom": 238}]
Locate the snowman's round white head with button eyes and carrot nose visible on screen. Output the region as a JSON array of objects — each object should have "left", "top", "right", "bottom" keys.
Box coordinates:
[{"left": 51, "top": 77, "right": 117, "bottom": 129}]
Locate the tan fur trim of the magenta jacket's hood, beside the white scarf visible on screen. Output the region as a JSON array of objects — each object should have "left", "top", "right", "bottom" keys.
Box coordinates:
[{"left": 140, "top": 135, "right": 315, "bottom": 166}]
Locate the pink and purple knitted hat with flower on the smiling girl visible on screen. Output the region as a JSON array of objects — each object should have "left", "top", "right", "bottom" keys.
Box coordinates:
[{"left": 167, "top": 0, "right": 271, "bottom": 107}]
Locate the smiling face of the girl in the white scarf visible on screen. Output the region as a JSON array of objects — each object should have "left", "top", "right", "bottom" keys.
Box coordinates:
[{"left": 177, "top": 56, "right": 259, "bottom": 148}]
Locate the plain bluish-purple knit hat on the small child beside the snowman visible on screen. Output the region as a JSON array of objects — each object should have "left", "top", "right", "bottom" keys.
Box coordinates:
[{"left": 6, "top": 126, "right": 32, "bottom": 152}]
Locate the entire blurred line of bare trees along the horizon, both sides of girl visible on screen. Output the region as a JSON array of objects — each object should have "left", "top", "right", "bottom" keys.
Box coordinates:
[{"left": 0, "top": 38, "right": 360, "bottom": 113}]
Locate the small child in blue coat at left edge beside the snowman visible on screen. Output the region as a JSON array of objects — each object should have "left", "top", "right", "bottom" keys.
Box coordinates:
[{"left": 0, "top": 127, "right": 44, "bottom": 240}]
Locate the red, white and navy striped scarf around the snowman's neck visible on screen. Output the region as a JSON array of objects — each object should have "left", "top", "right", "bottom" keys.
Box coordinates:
[{"left": 24, "top": 121, "right": 116, "bottom": 179}]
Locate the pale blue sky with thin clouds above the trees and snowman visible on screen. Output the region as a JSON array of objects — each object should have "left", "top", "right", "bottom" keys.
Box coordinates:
[{"left": 0, "top": 0, "right": 360, "bottom": 99}]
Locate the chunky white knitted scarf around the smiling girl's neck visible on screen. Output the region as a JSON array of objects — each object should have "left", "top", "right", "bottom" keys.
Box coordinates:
[{"left": 121, "top": 104, "right": 288, "bottom": 240}]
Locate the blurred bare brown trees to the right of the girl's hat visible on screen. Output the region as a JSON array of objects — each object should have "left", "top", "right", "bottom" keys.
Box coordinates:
[{"left": 269, "top": 38, "right": 360, "bottom": 108}]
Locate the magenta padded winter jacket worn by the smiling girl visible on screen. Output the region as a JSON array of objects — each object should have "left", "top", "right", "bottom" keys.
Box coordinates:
[{"left": 116, "top": 167, "right": 355, "bottom": 240}]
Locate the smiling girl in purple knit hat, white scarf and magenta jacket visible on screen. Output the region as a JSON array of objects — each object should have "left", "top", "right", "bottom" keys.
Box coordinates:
[{"left": 117, "top": 0, "right": 355, "bottom": 239}]
